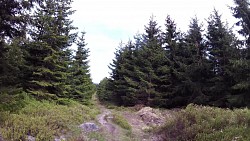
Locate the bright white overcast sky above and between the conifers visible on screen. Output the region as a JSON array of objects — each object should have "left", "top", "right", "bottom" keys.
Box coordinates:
[{"left": 71, "top": 0, "right": 235, "bottom": 83}]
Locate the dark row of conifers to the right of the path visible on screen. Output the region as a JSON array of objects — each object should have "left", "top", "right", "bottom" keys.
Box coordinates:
[{"left": 98, "top": 0, "right": 250, "bottom": 108}]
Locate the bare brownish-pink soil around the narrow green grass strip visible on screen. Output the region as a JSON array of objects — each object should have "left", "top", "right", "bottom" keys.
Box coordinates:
[{"left": 95, "top": 104, "right": 172, "bottom": 141}]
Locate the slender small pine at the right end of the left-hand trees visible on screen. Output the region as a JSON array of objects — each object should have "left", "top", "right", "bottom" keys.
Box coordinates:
[{"left": 70, "top": 32, "right": 94, "bottom": 104}]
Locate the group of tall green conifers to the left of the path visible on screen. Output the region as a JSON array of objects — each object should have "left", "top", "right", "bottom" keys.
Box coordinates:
[{"left": 0, "top": 0, "right": 95, "bottom": 107}]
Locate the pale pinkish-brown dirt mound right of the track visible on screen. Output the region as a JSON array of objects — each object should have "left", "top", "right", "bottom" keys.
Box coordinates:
[{"left": 137, "top": 107, "right": 165, "bottom": 126}]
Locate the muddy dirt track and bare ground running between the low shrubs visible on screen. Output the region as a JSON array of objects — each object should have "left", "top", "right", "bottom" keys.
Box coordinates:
[{"left": 95, "top": 93, "right": 166, "bottom": 141}]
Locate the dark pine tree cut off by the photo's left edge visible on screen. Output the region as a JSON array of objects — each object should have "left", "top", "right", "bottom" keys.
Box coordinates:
[{"left": 0, "top": 0, "right": 26, "bottom": 95}]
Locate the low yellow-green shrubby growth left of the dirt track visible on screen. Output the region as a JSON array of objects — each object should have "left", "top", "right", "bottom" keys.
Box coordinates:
[{"left": 0, "top": 99, "right": 98, "bottom": 141}]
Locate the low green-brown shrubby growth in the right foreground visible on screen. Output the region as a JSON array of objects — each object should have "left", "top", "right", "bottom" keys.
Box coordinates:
[{"left": 159, "top": 104, "right": 250, "bottom": 141}]
